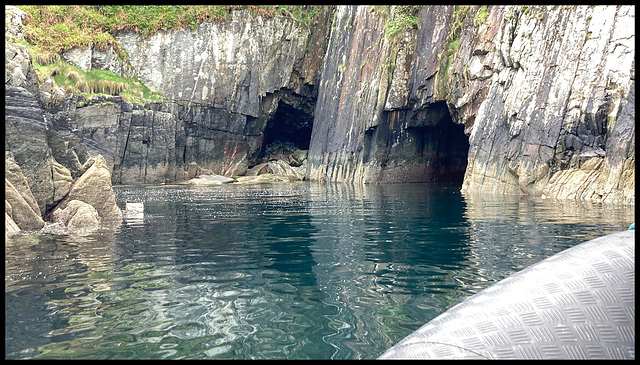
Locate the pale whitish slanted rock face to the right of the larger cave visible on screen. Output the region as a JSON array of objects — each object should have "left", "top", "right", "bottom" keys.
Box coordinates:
[{"left": 456, "top": 6, "right": 635, "bottom": 198}]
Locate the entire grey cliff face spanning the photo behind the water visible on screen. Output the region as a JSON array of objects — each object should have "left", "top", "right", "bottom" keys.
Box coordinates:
[{"left": 5, "top": 5, "right": 635, "bottom": 203}]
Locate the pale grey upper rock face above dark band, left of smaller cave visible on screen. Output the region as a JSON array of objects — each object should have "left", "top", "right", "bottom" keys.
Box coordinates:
[{"left": 116, "top": 10, "right": 310, "bottom": 117}]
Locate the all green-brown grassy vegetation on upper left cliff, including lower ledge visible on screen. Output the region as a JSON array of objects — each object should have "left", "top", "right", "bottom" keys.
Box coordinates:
[{"left": 13, "top": 5, "right": 318, "bottom": 103}]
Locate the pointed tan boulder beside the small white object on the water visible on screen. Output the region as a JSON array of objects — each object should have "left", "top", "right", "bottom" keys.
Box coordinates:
[{"left": 57, "top": 156, "right": 122, "bottom": 221}]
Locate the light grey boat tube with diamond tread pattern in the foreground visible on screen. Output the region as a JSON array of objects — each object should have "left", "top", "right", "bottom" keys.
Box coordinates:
[{"left": 380, "top": 230, "right": 635, "bottom": 359}]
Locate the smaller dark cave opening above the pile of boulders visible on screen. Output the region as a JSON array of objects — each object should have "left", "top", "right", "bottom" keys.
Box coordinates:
[{"left": 260, "top": 101, "right": 313, "bottom": 157}]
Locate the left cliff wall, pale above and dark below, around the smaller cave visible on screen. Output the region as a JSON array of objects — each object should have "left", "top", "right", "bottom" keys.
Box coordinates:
[{"left": 38, "top": 6, "right": 333, "bottom": 184}]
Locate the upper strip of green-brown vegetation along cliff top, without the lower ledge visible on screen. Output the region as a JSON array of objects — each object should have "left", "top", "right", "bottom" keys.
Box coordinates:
[{"left": 18, "top": 5, "right": 317, "bottom": 58}]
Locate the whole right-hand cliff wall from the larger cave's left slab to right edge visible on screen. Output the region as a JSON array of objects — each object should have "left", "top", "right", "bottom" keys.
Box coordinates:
[{"left": 307, "top": 5, "right": 635, "bottom": 203}]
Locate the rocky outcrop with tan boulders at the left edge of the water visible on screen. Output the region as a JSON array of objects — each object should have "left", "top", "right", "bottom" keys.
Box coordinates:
[{"left": 5, "top": 31, "right": 122, "bottom": 237}]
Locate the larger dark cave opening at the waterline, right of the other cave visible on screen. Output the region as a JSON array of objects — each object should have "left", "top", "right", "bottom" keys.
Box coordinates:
[{"left": 408, "top": 101, "right": 469, "bottom": 185}]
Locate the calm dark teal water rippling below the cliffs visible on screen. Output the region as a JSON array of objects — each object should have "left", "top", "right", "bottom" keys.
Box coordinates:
[{"left": 5, "top": 182, "right": 635, "bottom": 359}]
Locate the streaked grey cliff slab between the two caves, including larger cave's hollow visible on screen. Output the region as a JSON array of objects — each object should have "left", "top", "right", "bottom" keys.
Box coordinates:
[{"left": 307, "top": 6, "right": 468, "bottom": 183}]
